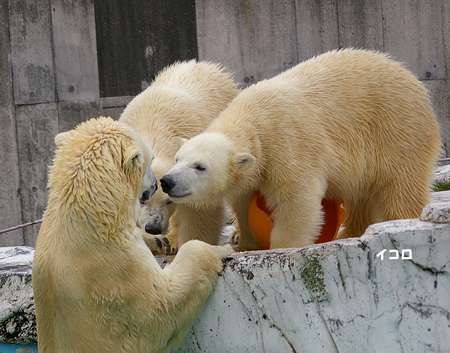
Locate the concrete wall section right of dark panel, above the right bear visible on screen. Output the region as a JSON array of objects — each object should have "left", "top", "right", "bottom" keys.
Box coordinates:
[{"left": 196, "top": 0, "right": 450, "bottom": 151}]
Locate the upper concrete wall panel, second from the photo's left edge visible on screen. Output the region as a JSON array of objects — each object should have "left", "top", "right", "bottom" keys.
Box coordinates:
[{"left": 10, "top": 0, "right": 55, "bottom": 105}]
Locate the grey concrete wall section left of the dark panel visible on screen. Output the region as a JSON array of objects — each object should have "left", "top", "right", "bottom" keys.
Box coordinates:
[{"left": 0, "top": 0, "right": 125, "bottom": 246}]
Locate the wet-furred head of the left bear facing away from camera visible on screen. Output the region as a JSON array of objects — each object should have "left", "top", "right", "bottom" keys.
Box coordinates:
[{"left": 49, "top": 117, "right": 156, "bottom": 227}]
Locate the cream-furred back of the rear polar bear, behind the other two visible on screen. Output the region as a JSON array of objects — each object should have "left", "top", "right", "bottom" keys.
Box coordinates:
[{"left": 120, "top": 60, "right": 238, "bottom": 162}]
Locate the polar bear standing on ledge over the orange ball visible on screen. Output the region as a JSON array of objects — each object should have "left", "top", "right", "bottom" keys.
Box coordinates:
[{"left": 161, "top": 49, "right": 441, "bottom": 250}]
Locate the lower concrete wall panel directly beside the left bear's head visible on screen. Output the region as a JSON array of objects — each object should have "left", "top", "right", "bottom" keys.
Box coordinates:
[{"left": 16, "top": 103, "right": 59, "bottom": 246}]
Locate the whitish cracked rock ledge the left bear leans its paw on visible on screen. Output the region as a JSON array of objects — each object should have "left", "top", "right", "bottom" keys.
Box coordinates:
[{"left": 0, "top": 192, "right": 450, "bottom": 353}]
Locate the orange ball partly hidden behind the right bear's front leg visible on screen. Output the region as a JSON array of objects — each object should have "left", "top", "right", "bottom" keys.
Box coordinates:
[{"left": 248, "top": 191, "right": 345, "bottom": 250}]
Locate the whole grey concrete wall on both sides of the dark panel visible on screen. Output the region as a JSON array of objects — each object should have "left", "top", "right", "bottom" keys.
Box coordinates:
[{"left": 0, "top": 0, "right": 450, "bottom": 246}]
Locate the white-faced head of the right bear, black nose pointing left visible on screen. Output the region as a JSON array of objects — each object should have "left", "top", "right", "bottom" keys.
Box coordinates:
[{"left": 161, "top": 133, "right": 256, "bottom": 204}]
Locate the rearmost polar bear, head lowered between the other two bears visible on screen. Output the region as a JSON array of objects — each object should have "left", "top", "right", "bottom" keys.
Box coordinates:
[{"left": 119, "top": 60, "right": 238, "bottom": 254}]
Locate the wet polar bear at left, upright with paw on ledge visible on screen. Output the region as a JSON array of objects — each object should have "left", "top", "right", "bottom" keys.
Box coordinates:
[{"left": 32, "top": 118, "right": 232, "bottom": 353}]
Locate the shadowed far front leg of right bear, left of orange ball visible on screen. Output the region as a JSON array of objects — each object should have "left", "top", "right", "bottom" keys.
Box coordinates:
[{"left": 231, "top": 192, "right": 260, "bottom": 251}]
